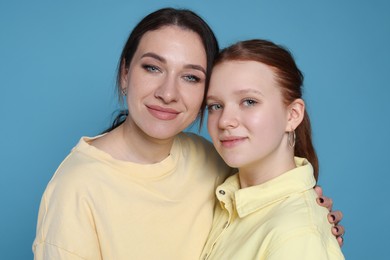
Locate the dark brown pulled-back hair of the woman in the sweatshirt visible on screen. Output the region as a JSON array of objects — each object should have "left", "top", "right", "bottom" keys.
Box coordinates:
[{"left": 105, "top": 8, "right": 219, "bottom": 132}]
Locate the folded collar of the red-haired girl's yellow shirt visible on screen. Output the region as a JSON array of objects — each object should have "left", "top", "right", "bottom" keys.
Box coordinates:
[{"left": 216, "top": 157, "right": 315, "bottom": 218}]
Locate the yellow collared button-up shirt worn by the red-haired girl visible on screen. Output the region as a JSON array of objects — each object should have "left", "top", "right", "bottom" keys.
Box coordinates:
[{"left": 202, "top": 157, "right": 344, "bottom": 260}]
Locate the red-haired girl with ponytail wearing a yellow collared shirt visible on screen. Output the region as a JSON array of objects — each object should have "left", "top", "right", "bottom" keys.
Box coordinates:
[{"left": 203, "top": 40, "right": 344, "bottom": 260}]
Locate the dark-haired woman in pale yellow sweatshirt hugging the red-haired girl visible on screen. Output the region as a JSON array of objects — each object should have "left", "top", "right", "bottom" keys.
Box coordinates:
[{"left": 33, "top": 8, "right": 340, "bottom": 259}]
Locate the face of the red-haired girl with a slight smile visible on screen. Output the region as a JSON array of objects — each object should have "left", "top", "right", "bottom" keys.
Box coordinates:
[{"left": 207, "top": 61, "right": 293, "bottom": 172}]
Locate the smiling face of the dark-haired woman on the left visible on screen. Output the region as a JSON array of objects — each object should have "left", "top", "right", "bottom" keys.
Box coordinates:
[{"left": 121, "top": 26, "right": 207, "bottom": 139}]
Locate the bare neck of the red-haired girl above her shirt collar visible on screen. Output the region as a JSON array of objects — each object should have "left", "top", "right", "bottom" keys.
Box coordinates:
[{"left": 238, "top": 153, "right": 296, "bottom": 189}]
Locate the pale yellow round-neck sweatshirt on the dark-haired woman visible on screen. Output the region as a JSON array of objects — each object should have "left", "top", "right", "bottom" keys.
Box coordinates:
[{"left": 33, "top": 134, "right": 231, "bottom": 260}]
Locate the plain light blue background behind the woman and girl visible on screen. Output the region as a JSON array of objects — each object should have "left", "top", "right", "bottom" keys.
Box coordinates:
[{"left": 0, "top": 0, "right": 390, "bottom": 259}]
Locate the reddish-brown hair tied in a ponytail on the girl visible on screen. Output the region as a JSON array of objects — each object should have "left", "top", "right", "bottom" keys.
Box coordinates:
[{"left": 214, "top": 39, "right": 319, "bottom": 180}]
